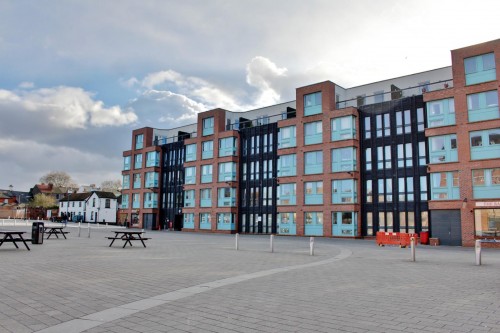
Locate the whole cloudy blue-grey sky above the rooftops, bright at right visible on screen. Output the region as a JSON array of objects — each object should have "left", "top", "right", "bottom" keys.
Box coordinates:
[{"left": 0, "top": 0, "right": 500, "bottom": 191}]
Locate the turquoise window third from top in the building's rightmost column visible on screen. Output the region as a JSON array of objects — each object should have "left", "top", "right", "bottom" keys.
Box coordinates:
[{"left": 469, "top": 128, "right": 500, "bottom": 160}]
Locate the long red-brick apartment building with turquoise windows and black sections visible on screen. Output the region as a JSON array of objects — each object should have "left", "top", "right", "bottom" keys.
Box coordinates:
[{"left": 120, "top": 40, "right": 500, "bottom": 246}]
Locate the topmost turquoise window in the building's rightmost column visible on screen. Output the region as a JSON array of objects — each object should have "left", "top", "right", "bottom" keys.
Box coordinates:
[{"left": 464, "top": 53, "right": 497, "bottom": 85}]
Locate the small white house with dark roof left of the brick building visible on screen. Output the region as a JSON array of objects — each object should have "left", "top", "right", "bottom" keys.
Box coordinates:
[{"left": 59, "top": 191, "right": 118, "bottom": 223}]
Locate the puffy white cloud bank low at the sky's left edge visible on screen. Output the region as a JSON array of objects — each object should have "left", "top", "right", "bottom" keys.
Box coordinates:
[{"left": 0, "top": 86, "right": 137, "bottom": 128}]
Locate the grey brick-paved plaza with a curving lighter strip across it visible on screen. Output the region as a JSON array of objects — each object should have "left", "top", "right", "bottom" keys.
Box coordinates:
[{"left": 0, "top": 225, "right": 500, "bottom": 333}]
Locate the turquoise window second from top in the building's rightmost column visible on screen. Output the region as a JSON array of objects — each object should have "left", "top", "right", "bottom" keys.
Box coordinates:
[{"left": 467, "top": 90, "right": 500, "bottom": 122}]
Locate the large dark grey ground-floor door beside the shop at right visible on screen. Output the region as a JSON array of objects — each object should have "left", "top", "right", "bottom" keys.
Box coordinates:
[{"left": 431, "top": 210, "right": 462, "bottom": 246}]
